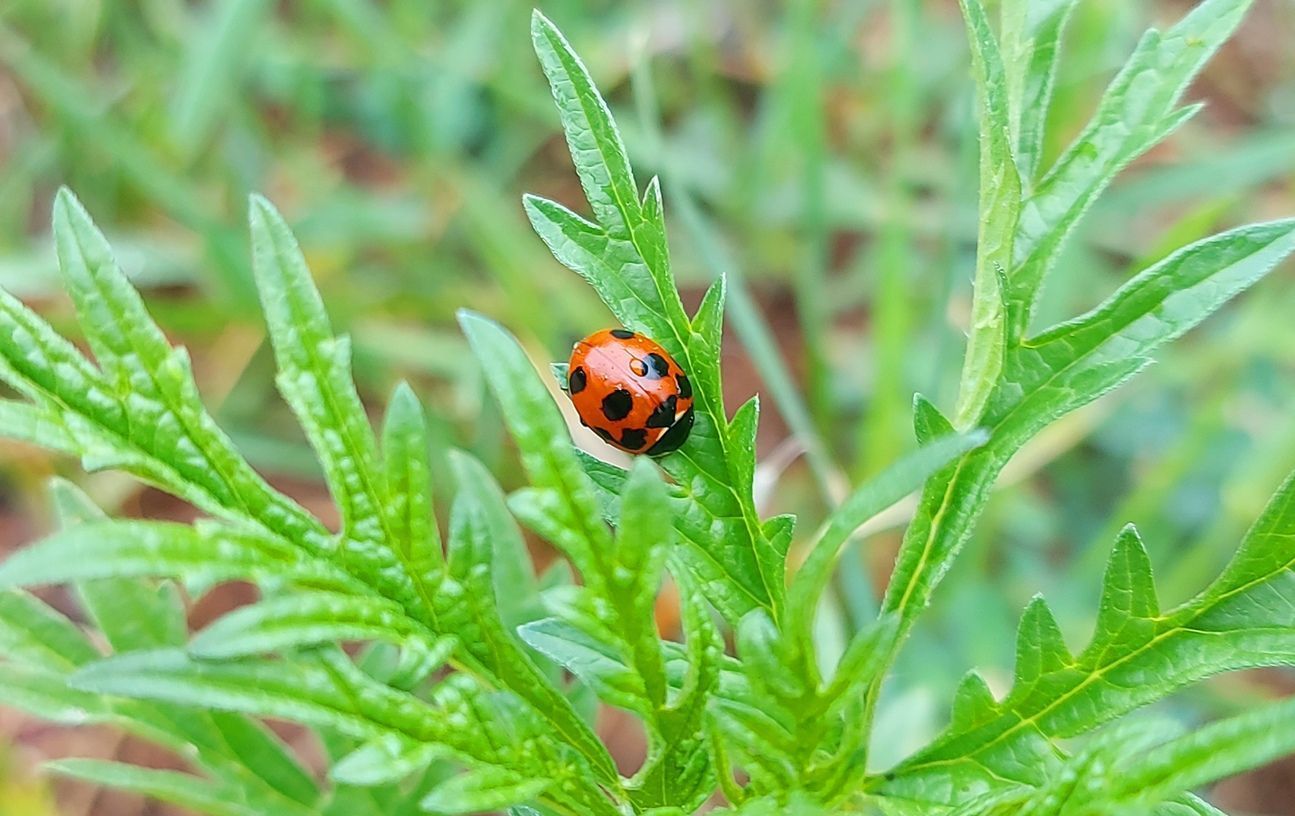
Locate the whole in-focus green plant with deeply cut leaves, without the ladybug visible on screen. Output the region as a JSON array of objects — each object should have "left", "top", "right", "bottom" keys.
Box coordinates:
[{"left": 0, "top": 0, "right": 1295, "bottom": 816}]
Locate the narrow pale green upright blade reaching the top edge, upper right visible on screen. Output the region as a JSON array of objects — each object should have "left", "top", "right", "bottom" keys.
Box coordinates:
[{"left": 954, "top": 0, "right": 1020, "bottom": 429}]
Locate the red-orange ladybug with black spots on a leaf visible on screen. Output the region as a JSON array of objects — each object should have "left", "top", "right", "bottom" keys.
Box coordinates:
[{"left": 567, "top": 329, "right": 693, "bottom": 456}]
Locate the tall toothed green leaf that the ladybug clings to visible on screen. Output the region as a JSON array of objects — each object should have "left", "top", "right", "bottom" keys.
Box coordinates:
[{"left": 526, "top": 13, "right": 781, "bottom": 622}]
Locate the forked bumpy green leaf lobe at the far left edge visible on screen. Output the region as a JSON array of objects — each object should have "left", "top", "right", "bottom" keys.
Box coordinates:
[{"left": 46, "top": 189, "right": 325, "bottom": 554}]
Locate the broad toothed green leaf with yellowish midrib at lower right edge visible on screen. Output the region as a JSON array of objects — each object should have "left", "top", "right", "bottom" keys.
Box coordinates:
[{"left": 879, "top": 468, "right": 1295, "bottom": 804}]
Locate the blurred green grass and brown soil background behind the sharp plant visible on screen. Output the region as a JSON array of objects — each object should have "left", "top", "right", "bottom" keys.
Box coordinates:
[{"left": 0, "top": 0, "right": 1295, "bottom": 813}]
